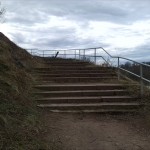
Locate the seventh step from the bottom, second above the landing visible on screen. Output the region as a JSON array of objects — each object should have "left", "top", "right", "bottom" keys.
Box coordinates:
[{"left": 35, "top": 72, "right": 116, "bottom": 79}]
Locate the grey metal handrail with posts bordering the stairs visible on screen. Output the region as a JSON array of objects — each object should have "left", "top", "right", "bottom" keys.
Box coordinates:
[{"left": 28, "top": 47, "right": 150, "bottom": 96}]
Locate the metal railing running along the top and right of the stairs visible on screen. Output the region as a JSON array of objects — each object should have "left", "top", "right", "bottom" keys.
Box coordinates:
[{"left": 28, "top": 47, "right": 150, "bottom": 96}]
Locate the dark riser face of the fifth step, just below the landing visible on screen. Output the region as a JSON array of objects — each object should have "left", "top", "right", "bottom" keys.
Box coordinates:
[{"left": 35, "top": 86, "right": 124, "bottom": 91}]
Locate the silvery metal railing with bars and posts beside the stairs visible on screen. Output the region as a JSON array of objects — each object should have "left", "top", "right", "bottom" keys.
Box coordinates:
[{"left": 27, "top": 47, "right": 150, "bottom": 96}]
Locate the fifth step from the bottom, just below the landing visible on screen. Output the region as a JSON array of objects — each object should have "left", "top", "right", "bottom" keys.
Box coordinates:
[{"left": 34, "top": 83, "right": 125, "bottom": 91}]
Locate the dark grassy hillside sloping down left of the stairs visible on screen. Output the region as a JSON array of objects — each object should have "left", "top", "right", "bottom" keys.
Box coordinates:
[{"left": 0, "top": 33, "right": 43, "bottom": 150}]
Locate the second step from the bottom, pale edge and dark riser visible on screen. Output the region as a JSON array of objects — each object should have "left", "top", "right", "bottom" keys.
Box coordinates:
[{"left": 38, "top": 102, "right": 141, "bottom": 111}]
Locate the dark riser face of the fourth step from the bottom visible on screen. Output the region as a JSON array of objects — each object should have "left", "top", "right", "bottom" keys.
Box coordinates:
[{"left": 37, "top": 91, "right": 127, "bottom": 97}]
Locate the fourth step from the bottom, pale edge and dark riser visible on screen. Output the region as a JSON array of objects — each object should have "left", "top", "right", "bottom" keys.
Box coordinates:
[{"left": 35, "top": 90, "right": 127, "bottom": 97}]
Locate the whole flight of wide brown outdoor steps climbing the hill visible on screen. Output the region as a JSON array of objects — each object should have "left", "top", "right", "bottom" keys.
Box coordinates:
[{"left": 34, "top": 59, "right": 141, "bottom": 112}]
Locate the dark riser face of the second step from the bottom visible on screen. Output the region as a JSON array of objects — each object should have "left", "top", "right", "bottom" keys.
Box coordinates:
[{"left": 37, "top": 105, "right": 140, "bottom": 111}]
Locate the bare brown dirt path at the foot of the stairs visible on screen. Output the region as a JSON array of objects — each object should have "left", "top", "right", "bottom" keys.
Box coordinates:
[{"left": 44, "top": 113, "right": 150, "bottom": 150}]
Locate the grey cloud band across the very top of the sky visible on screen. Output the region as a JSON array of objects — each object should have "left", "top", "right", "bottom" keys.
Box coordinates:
[{"left": 4, "top": 0, "right": 150, "bottom": 24}]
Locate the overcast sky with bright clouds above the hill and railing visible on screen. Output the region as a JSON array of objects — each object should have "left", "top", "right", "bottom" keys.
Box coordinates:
[{"left": 0, "top": 0, "right": 150, "bottom": 61}]
